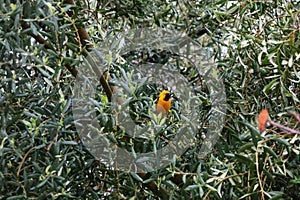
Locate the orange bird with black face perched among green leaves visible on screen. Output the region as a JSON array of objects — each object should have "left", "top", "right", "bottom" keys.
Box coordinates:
[{"left": 156, "top": 90, "right": 172, "bottom": 117}]
